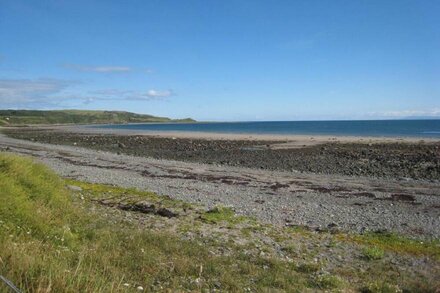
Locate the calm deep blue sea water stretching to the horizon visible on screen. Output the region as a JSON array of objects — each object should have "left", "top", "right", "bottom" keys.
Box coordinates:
[{"left": 92, "top": 120, "right": 440, "bottom": 138}]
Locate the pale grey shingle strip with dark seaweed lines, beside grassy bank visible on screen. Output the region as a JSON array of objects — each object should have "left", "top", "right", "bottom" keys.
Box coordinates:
[{"left": 0, "top": 131, "right": 440, "bottom": 238}]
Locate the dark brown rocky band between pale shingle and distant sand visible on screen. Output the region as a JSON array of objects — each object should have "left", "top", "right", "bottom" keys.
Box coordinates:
[{"left": 6, "top": 129, "right": 440, "bottom": 181}]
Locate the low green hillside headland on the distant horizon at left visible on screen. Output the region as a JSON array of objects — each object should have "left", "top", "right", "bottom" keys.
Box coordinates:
[{"left": 0, "top": 110, "right": 194, "bottom": 126}]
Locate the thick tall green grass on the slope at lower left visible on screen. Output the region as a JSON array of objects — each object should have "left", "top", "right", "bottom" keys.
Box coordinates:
[{"left": 0, "top": 153, "right": 306, "bottom": 292}]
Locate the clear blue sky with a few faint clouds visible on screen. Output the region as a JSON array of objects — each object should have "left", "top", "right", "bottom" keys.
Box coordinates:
[{"left": 0, "top": 0, "right": 440, "bottom": 121}]
